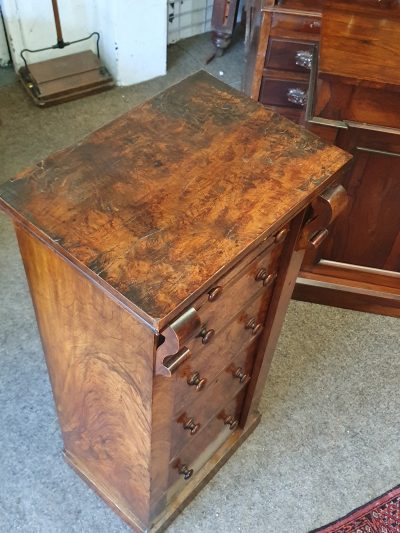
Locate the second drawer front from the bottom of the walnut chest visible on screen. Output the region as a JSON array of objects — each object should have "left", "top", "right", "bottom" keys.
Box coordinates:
[{"left": 171, "top": 344, "right": 256, "bottom": 457}]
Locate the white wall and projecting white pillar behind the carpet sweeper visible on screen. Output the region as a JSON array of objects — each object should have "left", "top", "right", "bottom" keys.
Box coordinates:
[{"left": 1, "top": 0, "right": 167, "bottom": 85}]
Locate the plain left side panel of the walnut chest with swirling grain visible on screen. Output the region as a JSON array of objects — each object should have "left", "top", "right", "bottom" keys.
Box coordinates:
[{"left": 16, "top": 228, "right": 154, "bottom": 525}]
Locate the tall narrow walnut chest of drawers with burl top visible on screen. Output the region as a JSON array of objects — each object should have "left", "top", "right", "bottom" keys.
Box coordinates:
[{"left": 0, "top": 72, "right": 349, "bottom": 531}]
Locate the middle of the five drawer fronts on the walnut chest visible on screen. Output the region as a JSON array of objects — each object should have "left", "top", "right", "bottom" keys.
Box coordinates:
[{"left": 174, "top": 287, "right": 272, "bottom": 413}]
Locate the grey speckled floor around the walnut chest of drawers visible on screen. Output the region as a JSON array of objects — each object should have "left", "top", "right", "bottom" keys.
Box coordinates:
[{"left": 0, "top": 30, "right": 400, "bottom": 533}]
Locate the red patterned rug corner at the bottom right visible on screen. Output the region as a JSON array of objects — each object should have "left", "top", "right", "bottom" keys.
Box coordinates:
[{"left": 310, "top": 485, "right": 400, "bottom": 533}]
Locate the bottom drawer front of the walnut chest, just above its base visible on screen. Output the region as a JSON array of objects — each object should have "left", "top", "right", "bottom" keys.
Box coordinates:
[{"left": 167, "top": 389, "right": 246, "bottom": 488}]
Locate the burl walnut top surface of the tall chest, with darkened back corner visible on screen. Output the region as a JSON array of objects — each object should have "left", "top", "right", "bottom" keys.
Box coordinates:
[{"left": 0, "top": 72, "right": 349, "bottom": 328}]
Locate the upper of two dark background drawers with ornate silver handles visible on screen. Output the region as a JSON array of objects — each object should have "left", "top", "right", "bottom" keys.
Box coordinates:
[{"left": 265, "top": 38, "right": 314, "bottom": 72}]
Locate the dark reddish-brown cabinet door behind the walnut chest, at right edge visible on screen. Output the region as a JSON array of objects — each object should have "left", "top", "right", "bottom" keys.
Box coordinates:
[{"left": 321, "top": 128, "right": 400, "bottom": 272}]
